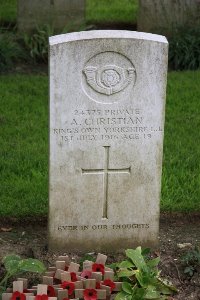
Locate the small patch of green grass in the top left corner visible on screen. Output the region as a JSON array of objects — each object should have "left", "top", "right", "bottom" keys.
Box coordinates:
[{"left": 0, "top": 0, "right": 17, "bottom": 23}]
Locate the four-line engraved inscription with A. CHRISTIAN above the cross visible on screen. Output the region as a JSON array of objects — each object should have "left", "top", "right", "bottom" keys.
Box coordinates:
[{"left": 53, "top": 107, "right": 163, "bottom": 143}]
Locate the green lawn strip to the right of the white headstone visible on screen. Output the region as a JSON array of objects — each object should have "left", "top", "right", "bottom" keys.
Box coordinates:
[{"left": 161, "top": 71, "right": 200, "bottom": 212}]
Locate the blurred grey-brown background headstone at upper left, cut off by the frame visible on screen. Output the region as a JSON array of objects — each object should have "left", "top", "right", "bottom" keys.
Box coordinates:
[{"left": 17, "top": 0, "right": 85, "bottom": 32}]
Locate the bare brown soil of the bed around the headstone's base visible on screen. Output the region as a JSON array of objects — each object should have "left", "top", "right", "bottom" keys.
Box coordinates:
[{"left": 0, "top": 213, "right": 200, "bottom": 300}]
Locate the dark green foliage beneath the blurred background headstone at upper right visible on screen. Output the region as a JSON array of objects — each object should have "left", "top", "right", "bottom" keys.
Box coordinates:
[{"left": 169, "top": 27, "right": 200, "bottom": 70}]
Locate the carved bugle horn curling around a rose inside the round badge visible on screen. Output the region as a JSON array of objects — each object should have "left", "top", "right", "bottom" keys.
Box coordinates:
[{"left": 83, "top": 65, "right": 135, "bottom": 95}]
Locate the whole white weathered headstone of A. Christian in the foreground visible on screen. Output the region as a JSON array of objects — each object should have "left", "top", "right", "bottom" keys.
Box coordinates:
[{"left": 49, "top": 31, "right": 168, "bottom": 252}]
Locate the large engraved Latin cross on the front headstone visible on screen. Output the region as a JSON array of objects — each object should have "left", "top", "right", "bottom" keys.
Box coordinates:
[{"left": 81, "top": 146, "right": 131, "bottom": 219}]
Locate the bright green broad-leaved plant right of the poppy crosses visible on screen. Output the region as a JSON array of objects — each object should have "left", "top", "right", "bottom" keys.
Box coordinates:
[{"left": 115, "top": 247, "right": 177, "bottom": 300}]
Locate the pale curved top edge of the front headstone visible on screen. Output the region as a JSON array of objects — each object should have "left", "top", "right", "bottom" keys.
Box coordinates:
[{"left": 49, "top": 30, "right": 168, "bottom": 46}]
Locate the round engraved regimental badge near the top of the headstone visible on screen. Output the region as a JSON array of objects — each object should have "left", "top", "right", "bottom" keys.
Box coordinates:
[{"left": 83, "top": 51, "right": 136, "bottom": 103}]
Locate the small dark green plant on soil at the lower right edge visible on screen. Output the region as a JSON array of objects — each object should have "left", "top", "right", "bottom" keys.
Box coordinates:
[{"left": 181, "top": 246, "right": 200, "bottom": 276}]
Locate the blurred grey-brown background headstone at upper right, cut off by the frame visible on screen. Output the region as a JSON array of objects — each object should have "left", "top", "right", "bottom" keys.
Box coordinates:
[{"left": 137, "top": 0, "right": 200, "bottom": 34}]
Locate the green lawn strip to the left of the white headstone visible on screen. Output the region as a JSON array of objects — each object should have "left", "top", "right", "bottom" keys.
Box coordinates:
[{"left": 0, "top": 76, "right": 48, "bottom": 216}]
